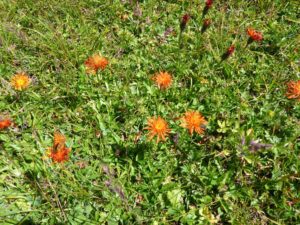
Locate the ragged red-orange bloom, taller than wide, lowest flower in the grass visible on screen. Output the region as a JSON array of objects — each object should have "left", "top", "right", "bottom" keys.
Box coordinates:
[{"left": 49, "top": 131, "right": 71, "bottom": 163}]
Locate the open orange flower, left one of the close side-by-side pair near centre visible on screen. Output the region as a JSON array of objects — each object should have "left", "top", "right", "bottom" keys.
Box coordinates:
[{"left": 145, "top": 117, "right": 171, "bottom": 143}]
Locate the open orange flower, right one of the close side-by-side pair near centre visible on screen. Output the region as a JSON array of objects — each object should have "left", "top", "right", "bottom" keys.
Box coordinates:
[{"left": 181, "top": 111, "right": 207, "bottom": 135}]
